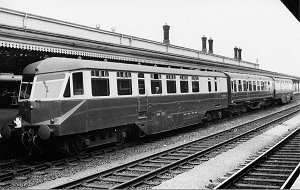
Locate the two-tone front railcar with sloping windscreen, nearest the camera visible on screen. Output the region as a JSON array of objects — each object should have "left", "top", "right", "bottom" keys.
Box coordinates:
[{"left": 2, "top": 58, "right": 228, "bottom": 153}]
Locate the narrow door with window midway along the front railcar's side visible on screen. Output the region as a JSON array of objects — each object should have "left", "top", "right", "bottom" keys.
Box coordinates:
[{"left": 138, "top": 73, "right": 148, "bottom": 119}]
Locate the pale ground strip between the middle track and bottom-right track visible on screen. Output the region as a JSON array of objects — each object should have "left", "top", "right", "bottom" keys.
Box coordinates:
[{"left": 153, "top": 114, "right": 300, "bottom": 189}]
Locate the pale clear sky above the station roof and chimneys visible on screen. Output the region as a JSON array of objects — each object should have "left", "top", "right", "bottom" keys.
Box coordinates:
[{"left": 0, "top": 0, "right": 300, "bottom": 77}]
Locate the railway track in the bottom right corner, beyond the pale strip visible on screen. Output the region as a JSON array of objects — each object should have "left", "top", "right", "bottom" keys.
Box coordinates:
[{"left": 215, "top": 128, "right": 300, "bottom": 189}]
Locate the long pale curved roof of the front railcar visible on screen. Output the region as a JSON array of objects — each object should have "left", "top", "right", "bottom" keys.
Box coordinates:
[{"left": 23, "top": 57, "right": 226, "bottom": 77}]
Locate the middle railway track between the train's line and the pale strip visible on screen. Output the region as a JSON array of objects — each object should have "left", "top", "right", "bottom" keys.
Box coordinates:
[{"left": 54, "top": 105, "right": 299, "bottom": 189}]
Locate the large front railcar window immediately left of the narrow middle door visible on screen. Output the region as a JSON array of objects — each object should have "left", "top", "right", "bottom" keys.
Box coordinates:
[{"left": 117, "top": 71, "right": 132, "bottom": 95}]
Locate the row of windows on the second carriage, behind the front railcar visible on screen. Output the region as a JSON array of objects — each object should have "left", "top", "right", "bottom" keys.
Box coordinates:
[{"left": 231, "top": 80, "right": 271, "bottom": 92}]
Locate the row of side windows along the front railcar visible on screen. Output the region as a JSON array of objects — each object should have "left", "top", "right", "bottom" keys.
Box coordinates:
[{"left": 64, "top": 70, "right": 218, "bottom": 97}]
